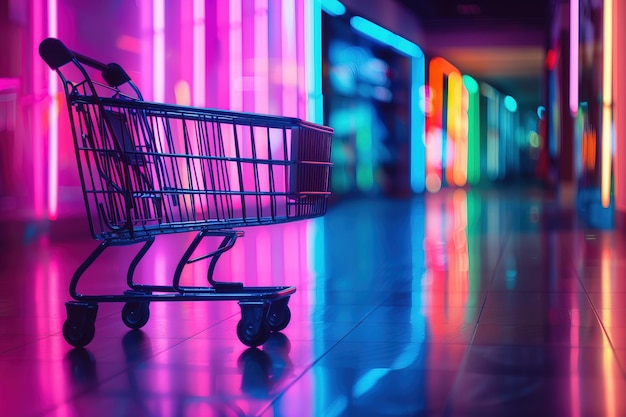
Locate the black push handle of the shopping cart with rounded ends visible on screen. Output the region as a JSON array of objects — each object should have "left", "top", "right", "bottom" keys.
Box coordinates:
[{"left": 39, "top": 38, "right": 130, "bottom": 88}]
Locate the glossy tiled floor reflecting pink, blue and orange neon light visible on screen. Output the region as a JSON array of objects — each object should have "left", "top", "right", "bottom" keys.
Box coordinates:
[{"left": 0, "top": 189, "right": 626, "bottom": 417}]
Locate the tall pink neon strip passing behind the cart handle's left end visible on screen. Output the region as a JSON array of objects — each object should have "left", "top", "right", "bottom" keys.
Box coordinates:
[{"left": 48, "top": 0, "right": 59, "bottom": 220}]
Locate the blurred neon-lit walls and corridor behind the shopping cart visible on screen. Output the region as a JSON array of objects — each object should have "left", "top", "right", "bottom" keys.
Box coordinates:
[{"left": 0, "top": 0, "right": 626, "bottom": 240}]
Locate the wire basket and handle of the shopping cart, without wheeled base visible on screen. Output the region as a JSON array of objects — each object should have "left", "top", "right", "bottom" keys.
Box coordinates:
[{"left": 40, "top": 39, "right": 333, "bottom": 239}]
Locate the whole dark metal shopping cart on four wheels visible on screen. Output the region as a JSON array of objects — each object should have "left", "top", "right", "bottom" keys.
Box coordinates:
[{"left": 39, "top": 38, "right": 333, "bottom": 347}]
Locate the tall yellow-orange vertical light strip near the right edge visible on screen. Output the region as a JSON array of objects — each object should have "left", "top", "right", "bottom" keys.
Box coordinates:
[{"left": 600, "top": 0, "right": 613, "bottom": 208}]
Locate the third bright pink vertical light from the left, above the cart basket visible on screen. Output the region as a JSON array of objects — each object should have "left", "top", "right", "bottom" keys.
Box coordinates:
[{"left": 193, "top": 0, "right": 206, "bottom": 107}]
